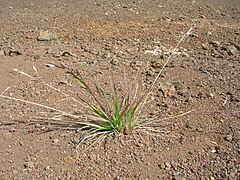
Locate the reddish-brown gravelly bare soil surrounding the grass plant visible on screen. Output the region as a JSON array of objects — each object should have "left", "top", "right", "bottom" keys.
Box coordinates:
[{"left": 0, "top": 0, "right": 240, "bottom": 180}]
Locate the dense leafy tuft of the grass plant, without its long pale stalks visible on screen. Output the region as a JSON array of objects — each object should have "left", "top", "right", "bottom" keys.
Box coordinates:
[{"left": 55, "top": 65, "right": 143, "bottom": 147}]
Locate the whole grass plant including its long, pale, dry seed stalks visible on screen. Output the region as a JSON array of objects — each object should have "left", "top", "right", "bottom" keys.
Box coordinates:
[{"left": 0, "top": 28, "right": 192, "bottom": 148}]
